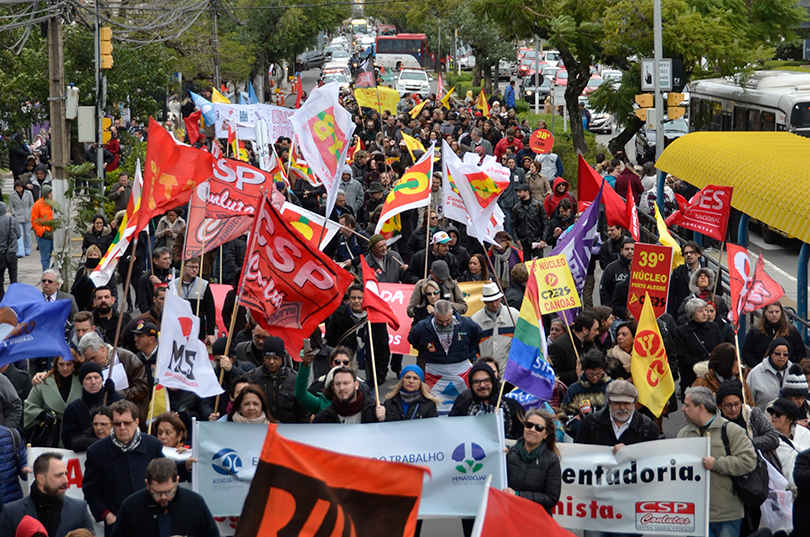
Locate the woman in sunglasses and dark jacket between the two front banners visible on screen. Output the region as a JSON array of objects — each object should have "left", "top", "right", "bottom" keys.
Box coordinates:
[{"left": 504, "top": 410, "right": 562, "bottom": 515}]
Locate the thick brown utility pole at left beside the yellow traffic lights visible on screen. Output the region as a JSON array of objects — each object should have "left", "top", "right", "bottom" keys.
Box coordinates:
[{"left": 48, "top": 13, "right": 70, "bottom": 268}]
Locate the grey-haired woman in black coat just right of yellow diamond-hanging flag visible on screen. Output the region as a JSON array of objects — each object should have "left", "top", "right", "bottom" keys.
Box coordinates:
[{"left": 675, "top": 298, "right": 723, "bottom": 394}]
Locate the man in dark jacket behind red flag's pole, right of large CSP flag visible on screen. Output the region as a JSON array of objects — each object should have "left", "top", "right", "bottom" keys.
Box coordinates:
[{"left": 324, "top": 284, "right": 391, "bottom": 393}]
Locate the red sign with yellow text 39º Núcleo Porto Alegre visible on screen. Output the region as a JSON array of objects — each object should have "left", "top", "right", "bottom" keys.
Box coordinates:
[{"left": 627, "top": 242, "right": 672, "bottom": 319}]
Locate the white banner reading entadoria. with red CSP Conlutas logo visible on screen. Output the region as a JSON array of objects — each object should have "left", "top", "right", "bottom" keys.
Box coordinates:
[{"left": 556, "top": 438, "right": 709, "bottom": 535}]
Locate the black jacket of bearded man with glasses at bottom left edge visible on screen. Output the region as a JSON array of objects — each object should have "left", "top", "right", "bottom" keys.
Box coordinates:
[{"left": 112, "top": 487, "right": 219, "bottom": 537}]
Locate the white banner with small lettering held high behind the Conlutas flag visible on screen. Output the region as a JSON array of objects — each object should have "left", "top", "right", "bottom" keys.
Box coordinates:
[{"left": 214, "top": 103, "right": 295, "bottom": 144}]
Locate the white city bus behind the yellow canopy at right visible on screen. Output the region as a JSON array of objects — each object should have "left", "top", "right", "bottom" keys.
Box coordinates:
[{"left": 689, "top": 71, "right": 810, "bottom": 137}]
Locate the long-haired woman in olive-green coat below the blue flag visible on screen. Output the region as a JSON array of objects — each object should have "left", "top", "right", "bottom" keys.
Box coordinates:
[{"left": 24, "top": 351, "right": 82, "bottom": 448}]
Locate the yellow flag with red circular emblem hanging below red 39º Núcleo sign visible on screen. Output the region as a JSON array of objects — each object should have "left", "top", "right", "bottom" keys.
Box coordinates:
[{"left": 630, "top": 293, "right": 675, "bottom": 417}]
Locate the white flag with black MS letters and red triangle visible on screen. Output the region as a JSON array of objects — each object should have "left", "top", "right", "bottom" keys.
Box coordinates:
[{"left": 155, "top": 293, "right": 224, "bottom": 398}]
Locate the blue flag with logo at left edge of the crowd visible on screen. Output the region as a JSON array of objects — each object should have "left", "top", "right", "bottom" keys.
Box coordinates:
[{"left": 0, "top": 283, "right": 73, "bottom": 366}]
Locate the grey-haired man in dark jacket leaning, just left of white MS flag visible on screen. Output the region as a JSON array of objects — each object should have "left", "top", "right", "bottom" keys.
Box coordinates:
[{"left": 79, "top": 332, "right": 150, "bottom": 430}]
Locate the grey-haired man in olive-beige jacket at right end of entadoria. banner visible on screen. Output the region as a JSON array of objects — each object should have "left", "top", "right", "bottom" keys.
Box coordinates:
[{"left": 678, "top": 386, "right": 757, "bottom": 537}]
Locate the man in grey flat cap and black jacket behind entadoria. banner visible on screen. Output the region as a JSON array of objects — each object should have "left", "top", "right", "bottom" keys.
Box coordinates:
[{"left": 575, "top": 380, "right": 660, "bottom": 446}]
